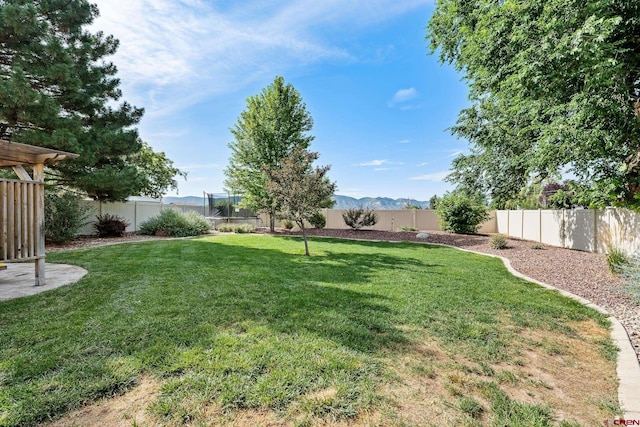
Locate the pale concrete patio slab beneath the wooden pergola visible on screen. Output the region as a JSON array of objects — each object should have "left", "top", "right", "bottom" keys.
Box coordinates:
[{"left": 0, "top": 263, "right": 87, "bottom": 301}]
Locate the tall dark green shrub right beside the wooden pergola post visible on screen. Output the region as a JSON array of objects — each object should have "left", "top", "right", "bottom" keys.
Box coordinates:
[{"left": 44, "top": 191, "right": 91, "bottom": 243}]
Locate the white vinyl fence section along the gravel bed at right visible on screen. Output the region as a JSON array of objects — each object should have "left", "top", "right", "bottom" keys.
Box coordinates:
[{"left": 496, "top": 208, "right": 640, "bottom": 254}]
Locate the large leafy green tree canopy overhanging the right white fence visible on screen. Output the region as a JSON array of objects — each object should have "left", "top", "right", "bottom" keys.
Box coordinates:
[{"left": 427, "top": 0, "right": 640, "bottom": 208}]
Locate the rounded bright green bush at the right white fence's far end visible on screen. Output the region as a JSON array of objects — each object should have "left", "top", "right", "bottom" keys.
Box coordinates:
[{"left": 436, "top": 192, "right": 489, "bottom": 234}]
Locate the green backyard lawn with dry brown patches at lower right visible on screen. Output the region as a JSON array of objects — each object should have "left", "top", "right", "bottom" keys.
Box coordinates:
[{"left": 0, "top": 235, "right": 619, "bottom": 426}]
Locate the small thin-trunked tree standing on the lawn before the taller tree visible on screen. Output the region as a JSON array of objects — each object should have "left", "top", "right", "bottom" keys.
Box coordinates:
[{"left": 264, "top": 147, "right": 336, "bottom": 256}]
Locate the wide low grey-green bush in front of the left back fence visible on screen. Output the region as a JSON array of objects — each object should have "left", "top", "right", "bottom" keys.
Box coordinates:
[{"left": 140, "top": 209, "right": 210, "bottom": 237}]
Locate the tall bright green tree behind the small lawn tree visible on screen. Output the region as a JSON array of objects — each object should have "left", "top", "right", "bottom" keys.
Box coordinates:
[{"left": 225, "top": 76, "right": 314, "bottom": 231}]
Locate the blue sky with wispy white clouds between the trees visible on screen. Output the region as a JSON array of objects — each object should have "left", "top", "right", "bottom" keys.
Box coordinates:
[{"left": 92, "top": 0, "right": 468, "bottom": 200}]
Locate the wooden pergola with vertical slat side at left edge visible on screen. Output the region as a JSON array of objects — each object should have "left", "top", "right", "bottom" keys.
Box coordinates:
[{"left": 0, "top": 140, "right": 78, "bottom": 286}]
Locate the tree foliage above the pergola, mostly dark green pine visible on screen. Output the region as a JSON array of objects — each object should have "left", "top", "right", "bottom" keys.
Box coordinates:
[{"left": 0, "top": 0, "right": 183, "bottom": 200}]
